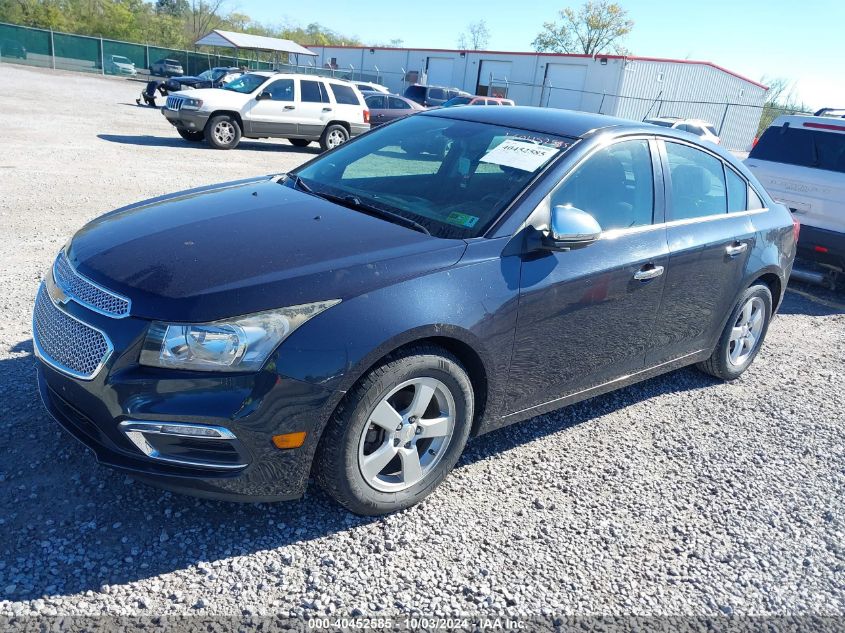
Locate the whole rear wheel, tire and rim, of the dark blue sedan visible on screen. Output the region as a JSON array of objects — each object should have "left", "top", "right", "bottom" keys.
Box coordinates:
[{"left": 698, "top": 284, "right": 772, "bottom": 380}]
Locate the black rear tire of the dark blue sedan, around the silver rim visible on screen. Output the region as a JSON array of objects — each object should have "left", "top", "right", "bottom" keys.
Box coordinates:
[{"left": 697, "top": 284, "right": 772, "bottom": 380}]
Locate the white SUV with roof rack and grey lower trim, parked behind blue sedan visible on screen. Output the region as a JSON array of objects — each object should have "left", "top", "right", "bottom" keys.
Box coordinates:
[{"left": 162, "top": 72, "right": 370, "bottom": 150}]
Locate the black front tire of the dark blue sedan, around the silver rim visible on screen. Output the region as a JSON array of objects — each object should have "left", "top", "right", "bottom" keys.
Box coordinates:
[{"left": 314, "top": 346, "right": 474, "bottom": 516}]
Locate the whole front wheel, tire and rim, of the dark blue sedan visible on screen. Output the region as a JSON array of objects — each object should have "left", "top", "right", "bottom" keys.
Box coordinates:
[{"left": 314, "top": 347, "right": 474, "bottom": 516}]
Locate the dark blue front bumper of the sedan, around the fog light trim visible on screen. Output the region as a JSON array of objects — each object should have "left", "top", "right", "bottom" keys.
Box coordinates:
[{"left": 33, "top": 282, "right": 342, "bottom": 502}]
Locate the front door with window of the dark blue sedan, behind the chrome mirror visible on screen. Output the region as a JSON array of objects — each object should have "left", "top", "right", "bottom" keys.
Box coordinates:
[{"left": 505, "top": 138, "right": 668, "bottom": 413}]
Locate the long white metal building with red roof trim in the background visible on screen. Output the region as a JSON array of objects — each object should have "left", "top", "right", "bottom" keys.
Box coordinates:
[{"left": 309, "top": 46, "right": 767, "bottom": 150}]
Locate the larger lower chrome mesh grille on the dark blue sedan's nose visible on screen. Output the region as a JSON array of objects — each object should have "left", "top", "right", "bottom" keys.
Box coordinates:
[{"left": 32, "top": 284, "right": 112, "bottom": 380}]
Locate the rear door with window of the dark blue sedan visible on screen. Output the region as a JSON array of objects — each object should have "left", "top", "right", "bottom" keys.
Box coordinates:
[{"left": 647, "top": 139, "right": 762, "bottom": 365}]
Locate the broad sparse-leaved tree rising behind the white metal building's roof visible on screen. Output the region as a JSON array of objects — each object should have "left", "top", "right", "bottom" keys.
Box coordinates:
[{"left": 532, "top": 0, "right": 634, "bottom": 55}]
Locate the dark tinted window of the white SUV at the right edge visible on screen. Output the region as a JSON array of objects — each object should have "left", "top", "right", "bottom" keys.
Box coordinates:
[{"left": 749, "top": 126, "right": 845, "bottom": 173}]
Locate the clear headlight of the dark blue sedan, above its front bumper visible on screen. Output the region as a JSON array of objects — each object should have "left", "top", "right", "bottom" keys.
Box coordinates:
[{"left": 140, "top": 299, "right": 340, "bottom": 371}]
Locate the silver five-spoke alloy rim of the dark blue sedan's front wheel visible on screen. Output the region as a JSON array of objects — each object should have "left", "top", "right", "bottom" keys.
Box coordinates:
[{"left": 358, "top": 378, "right": 456, "bottom": 492}]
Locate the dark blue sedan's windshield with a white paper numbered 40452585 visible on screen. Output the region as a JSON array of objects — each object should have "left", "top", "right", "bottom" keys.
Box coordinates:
[{"left": 287, "top": 115, "right": 574, "bottom": 239}]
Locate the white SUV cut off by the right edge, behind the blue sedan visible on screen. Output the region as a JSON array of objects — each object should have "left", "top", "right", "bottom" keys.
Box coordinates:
[{"left": 745, "top": 110, "right": 845, "bottom": 272}]
